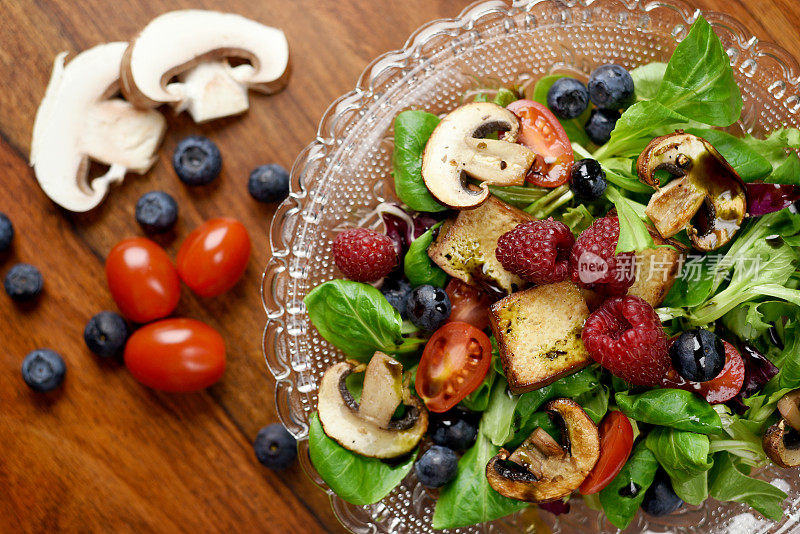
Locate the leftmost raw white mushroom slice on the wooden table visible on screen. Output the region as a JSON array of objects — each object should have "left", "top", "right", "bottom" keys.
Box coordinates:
[{"left": 30, "top": 42, "right": 166, "bottom": 212}]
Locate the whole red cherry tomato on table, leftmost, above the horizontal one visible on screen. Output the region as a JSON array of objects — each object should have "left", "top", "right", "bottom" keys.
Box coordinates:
[{"left": 106, "top": 237, "right": 181, "bottom": 323}]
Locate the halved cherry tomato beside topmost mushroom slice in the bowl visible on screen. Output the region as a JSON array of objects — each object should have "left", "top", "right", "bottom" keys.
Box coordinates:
[{"left": 508, "top": 100, "right": 575, "bottom": 187}]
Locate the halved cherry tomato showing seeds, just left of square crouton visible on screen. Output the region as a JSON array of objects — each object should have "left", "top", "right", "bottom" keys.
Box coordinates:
[{"left": 414, "top": 322, "right": 492, "bottom": 412}]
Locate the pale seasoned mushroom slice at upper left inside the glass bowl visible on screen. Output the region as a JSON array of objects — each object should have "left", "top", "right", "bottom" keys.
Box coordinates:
[{"left": 422, "top": 102, "right": 536, "bottom": 209}]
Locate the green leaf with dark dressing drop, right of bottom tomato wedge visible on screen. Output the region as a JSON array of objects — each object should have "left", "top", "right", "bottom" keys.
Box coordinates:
[{"left": 600, "top": 442, "right": 658, "bottom": 530}]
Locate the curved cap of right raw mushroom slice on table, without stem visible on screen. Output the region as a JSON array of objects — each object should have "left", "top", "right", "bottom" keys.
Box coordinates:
[{"left": 121, "top": 9, "right": 289, "bottom": 107}]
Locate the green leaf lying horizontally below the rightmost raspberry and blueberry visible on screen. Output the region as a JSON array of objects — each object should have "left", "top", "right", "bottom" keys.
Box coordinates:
[{"left": 614, "top": 389, "right": 722, "bottom": 434}]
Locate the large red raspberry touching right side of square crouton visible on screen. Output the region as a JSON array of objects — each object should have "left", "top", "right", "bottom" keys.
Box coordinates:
[{"left": 581, "top": 295, "right": 671, "bottom": 387}]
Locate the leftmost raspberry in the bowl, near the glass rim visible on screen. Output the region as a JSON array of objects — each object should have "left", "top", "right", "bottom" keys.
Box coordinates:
[{"left": 333, "top": 228, "right": 397, "bottom": 282}]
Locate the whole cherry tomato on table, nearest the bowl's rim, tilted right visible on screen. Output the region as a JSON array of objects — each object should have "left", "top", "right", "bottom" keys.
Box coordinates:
[{"left": 177, "top": 218, "right": 250, "bottom": 297}]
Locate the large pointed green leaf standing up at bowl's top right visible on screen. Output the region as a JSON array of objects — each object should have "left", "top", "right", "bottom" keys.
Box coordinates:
[{"left": 656, "top": 16, "right": 743, "bottom": 126}]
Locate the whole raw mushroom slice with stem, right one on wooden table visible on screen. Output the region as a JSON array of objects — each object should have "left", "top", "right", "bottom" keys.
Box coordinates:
[{"left": 121, "top": 9, "right": 289, "bottom": 122}]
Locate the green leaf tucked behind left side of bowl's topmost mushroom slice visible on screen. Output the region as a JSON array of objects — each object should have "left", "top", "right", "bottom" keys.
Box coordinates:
[{"left": 392, "top": 110, "right": 447, "bottom": 211}]
